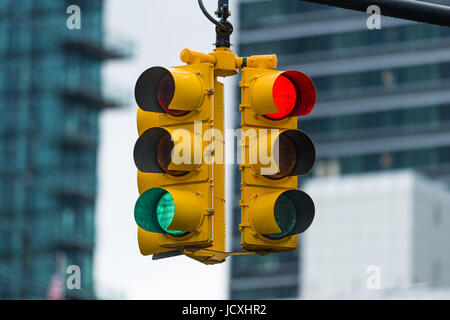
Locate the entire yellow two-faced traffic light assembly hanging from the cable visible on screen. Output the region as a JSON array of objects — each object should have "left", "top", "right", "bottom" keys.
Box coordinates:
[{"left": 134, "top": 42, "right": 316, "bottom": 264}]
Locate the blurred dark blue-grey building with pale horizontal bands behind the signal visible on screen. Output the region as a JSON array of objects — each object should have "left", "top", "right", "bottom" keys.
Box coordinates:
[{"left": 230, "top": 0, "right": 450, "bottom": 299}]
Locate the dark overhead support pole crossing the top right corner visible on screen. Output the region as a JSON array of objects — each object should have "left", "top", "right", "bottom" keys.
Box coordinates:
[{"left": 300, "top": 0, "right": 450, "bottom": 27}]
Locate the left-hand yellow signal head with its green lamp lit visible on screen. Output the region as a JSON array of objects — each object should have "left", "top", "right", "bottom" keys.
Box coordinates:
[{"left": 134, "top": 63, "right": 225, "bottom": 259}]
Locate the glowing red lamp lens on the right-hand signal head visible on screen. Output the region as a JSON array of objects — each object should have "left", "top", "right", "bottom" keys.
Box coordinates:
[{"left": 266, "top": 75, "right": 297, "bottom": 120}]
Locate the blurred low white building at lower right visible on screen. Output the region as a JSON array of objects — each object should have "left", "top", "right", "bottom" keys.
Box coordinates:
[{"left": 300, "top": 170, "right": 450, "bottom": 299}]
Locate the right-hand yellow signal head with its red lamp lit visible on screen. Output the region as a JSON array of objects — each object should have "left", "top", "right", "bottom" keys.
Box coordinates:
[{"left": 239, "top": 63, "right": 316, "bottom": 254}]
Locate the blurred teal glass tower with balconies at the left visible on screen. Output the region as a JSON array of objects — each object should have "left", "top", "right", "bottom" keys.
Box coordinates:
[{"left": 0, "top": 0, "right": 130, "bottom": 299}]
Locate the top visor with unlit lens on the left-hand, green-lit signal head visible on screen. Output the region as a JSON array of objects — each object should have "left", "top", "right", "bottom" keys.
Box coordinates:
[{"left": 134, "top": 67, "right": 202, "bottom": 116}]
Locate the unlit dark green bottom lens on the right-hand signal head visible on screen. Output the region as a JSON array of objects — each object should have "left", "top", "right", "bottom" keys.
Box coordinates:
[{"left": 265, "top": 193, "right": 297, "bottom": 239}]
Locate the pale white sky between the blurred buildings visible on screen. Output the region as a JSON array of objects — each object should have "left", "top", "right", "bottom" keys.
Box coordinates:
[{"left": 94, "top": 0, "right": 238, "bottom": 299}]
